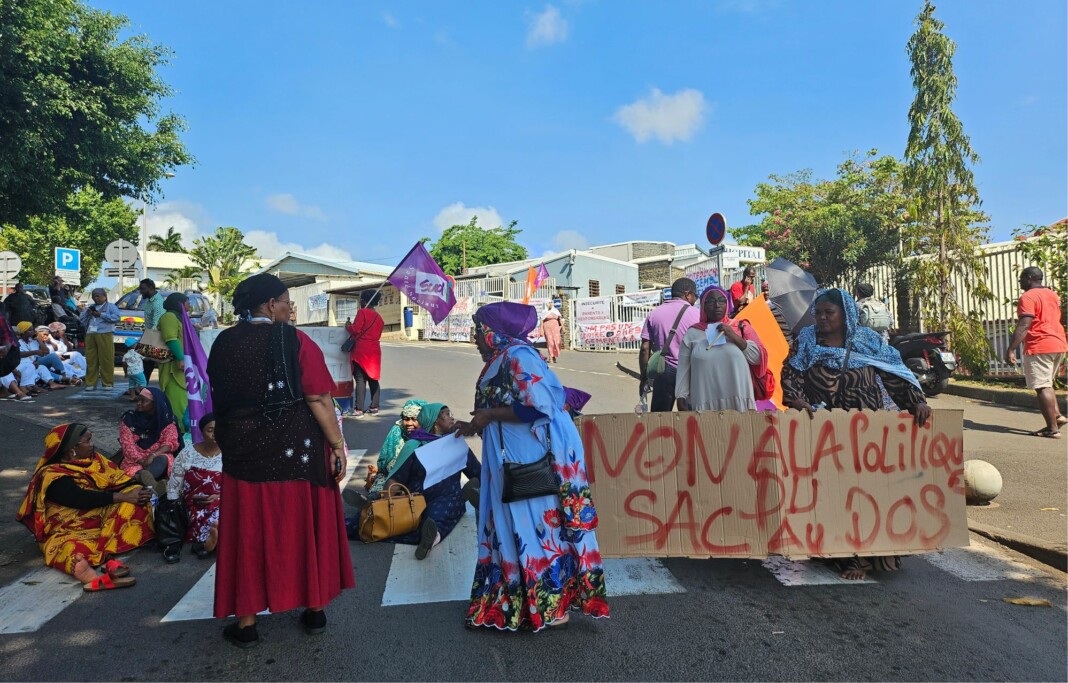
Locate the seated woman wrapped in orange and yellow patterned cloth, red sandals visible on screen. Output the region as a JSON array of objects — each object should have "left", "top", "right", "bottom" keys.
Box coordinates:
[{"left": 16, "top": 423, "right": 155, "bottom": 591}]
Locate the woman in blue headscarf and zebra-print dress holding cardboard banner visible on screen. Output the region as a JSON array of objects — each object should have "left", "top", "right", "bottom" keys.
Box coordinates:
[{"left": 782, "top": 289, "right": 930, "bottom": 579}]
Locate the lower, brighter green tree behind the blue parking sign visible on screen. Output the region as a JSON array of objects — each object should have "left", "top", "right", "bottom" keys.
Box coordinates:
[{"left": 0, "top": 189, "right": 138, "bottom": 287}]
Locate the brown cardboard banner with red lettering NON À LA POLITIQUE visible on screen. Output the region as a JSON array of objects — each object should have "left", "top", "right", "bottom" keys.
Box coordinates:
[{"left": 576, "top": 410, "right": 969, "bottom": 558}]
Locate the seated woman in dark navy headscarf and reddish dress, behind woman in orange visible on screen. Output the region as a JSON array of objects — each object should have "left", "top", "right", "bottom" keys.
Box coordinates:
[{"left": 119, "top": 387, "right": 178, "bottom": 496}]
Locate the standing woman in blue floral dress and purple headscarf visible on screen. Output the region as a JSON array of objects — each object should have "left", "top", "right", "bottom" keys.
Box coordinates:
[{"left": 460, "top": 302, "right": 609, "bottom": 631}]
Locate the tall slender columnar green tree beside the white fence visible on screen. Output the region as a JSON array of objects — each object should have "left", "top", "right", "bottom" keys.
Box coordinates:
[{"left": 905, "top": 0, "right": 992, "bottom": 375}]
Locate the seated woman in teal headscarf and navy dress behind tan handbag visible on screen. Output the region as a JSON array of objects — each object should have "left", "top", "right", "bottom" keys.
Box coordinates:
[{"left": 344, "top": 403, "right": 482, "bottom": 559}]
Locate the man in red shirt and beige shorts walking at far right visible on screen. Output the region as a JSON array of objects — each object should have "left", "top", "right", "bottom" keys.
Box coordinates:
[{"left": 1005, "top": 266, "right": 1068, "bottom": 439}]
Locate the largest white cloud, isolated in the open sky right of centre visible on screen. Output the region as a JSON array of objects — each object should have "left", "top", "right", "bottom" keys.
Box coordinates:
[{"left": 613, "top": 88, "right": 709, "bottom": 145}]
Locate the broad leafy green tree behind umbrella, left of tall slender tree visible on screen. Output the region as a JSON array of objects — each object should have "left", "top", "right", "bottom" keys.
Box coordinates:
[{"left": 731, "top": 149, "right": 906, "bottom": 284}]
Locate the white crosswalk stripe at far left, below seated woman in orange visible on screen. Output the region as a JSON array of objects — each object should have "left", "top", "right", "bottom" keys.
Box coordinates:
[{"left": 0, "top": 567, "right": 84, "bottom": 634}]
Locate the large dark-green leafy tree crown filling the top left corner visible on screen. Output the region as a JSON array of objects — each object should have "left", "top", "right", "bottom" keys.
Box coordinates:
[{"left": 0, "top": 0, "right": 193, "bottom": 227}]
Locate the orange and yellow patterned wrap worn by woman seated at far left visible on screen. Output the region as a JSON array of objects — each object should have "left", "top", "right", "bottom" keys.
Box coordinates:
[{"left": 15, "top": 425, "right": 156, "bottom": 574}]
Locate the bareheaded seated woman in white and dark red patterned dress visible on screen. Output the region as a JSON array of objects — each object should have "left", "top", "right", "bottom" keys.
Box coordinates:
[{"left": 167, "top": 413, "right": 222, "bottom": 559}]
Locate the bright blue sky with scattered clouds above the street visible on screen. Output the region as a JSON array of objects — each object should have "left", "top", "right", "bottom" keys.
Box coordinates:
[{"left": 93, "top": 0, "right": 1068, "bottom": 263}]
